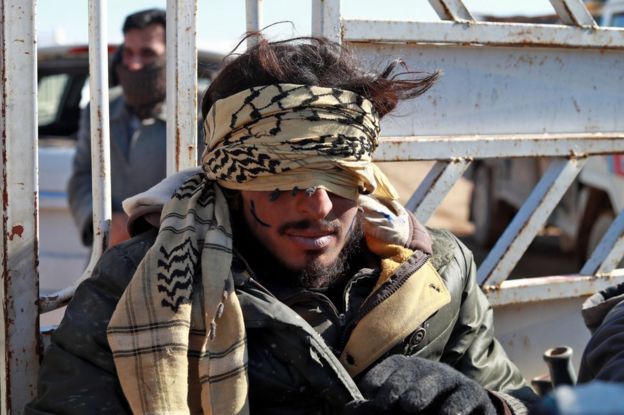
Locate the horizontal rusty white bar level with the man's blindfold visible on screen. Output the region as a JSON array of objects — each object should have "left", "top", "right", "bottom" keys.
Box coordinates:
[{"left": 375, "top": 132, "right": 624, "bottom": 161}]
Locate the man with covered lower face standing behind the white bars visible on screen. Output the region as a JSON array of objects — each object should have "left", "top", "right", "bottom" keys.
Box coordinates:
[{"left": 68, "top": 9, "right": 167, "bottom": 246}]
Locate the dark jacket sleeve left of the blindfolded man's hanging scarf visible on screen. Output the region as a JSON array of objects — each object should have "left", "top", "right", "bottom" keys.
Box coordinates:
[{"left": 25, "top": 231, "right": 155, "bottom": 415}]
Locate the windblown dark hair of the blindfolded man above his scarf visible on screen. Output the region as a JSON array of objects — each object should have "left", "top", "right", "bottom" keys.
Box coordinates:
[{"left": 202, "top": 35, "right": 439, "bottom": 118}]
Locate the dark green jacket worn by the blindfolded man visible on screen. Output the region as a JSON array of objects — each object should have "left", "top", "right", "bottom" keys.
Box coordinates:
[{"left": 26, "top": 226, "right": 535, "bottom": 415}]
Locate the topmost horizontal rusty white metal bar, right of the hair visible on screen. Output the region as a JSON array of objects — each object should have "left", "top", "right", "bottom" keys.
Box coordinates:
[{"left": 342, "top": 20, "right": 624, "bottom": 49}]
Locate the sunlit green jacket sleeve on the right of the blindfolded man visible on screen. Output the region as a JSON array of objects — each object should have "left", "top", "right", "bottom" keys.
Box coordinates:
[{"left": 441, "top": 236, "right": 538, "bottom": 413}]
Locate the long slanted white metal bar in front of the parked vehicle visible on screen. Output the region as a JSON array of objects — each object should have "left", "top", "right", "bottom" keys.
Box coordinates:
[{"left": 477, "top": 158, "right": 587, "bottom": 285}]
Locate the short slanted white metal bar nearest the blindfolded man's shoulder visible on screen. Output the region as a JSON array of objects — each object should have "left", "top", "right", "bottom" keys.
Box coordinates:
[{"left": 405, "top": 159, "right": 472, "bottom": 223}]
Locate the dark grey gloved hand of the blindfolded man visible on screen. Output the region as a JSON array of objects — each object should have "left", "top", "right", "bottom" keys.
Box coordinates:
[{"left": 343, "top": 355, "right": 496, "bottom": 415}]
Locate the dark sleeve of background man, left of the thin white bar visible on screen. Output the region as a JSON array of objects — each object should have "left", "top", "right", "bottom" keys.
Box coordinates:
[{"left": 67, "top": 107, "right": 93, "bottom": 245}]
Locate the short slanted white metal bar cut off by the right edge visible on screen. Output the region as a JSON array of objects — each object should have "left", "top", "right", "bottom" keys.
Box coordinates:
[{"left": 580, "top": 210, "right": 624, "bottom": 275}]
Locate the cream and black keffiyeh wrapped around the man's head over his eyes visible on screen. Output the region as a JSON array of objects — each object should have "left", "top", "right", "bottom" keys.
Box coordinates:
[{"left": 202, "top": 84, "right": 398, "bottom": 200}]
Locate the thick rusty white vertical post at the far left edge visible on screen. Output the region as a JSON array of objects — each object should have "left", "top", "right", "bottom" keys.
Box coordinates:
[{"left": 0, "top": 0, "right": 39, "bottom": 415}]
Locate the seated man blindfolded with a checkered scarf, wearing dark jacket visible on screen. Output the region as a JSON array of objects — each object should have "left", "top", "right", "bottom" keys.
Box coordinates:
[{"left": 30, "top": 39, "right": 535, "bottom": 415}]
